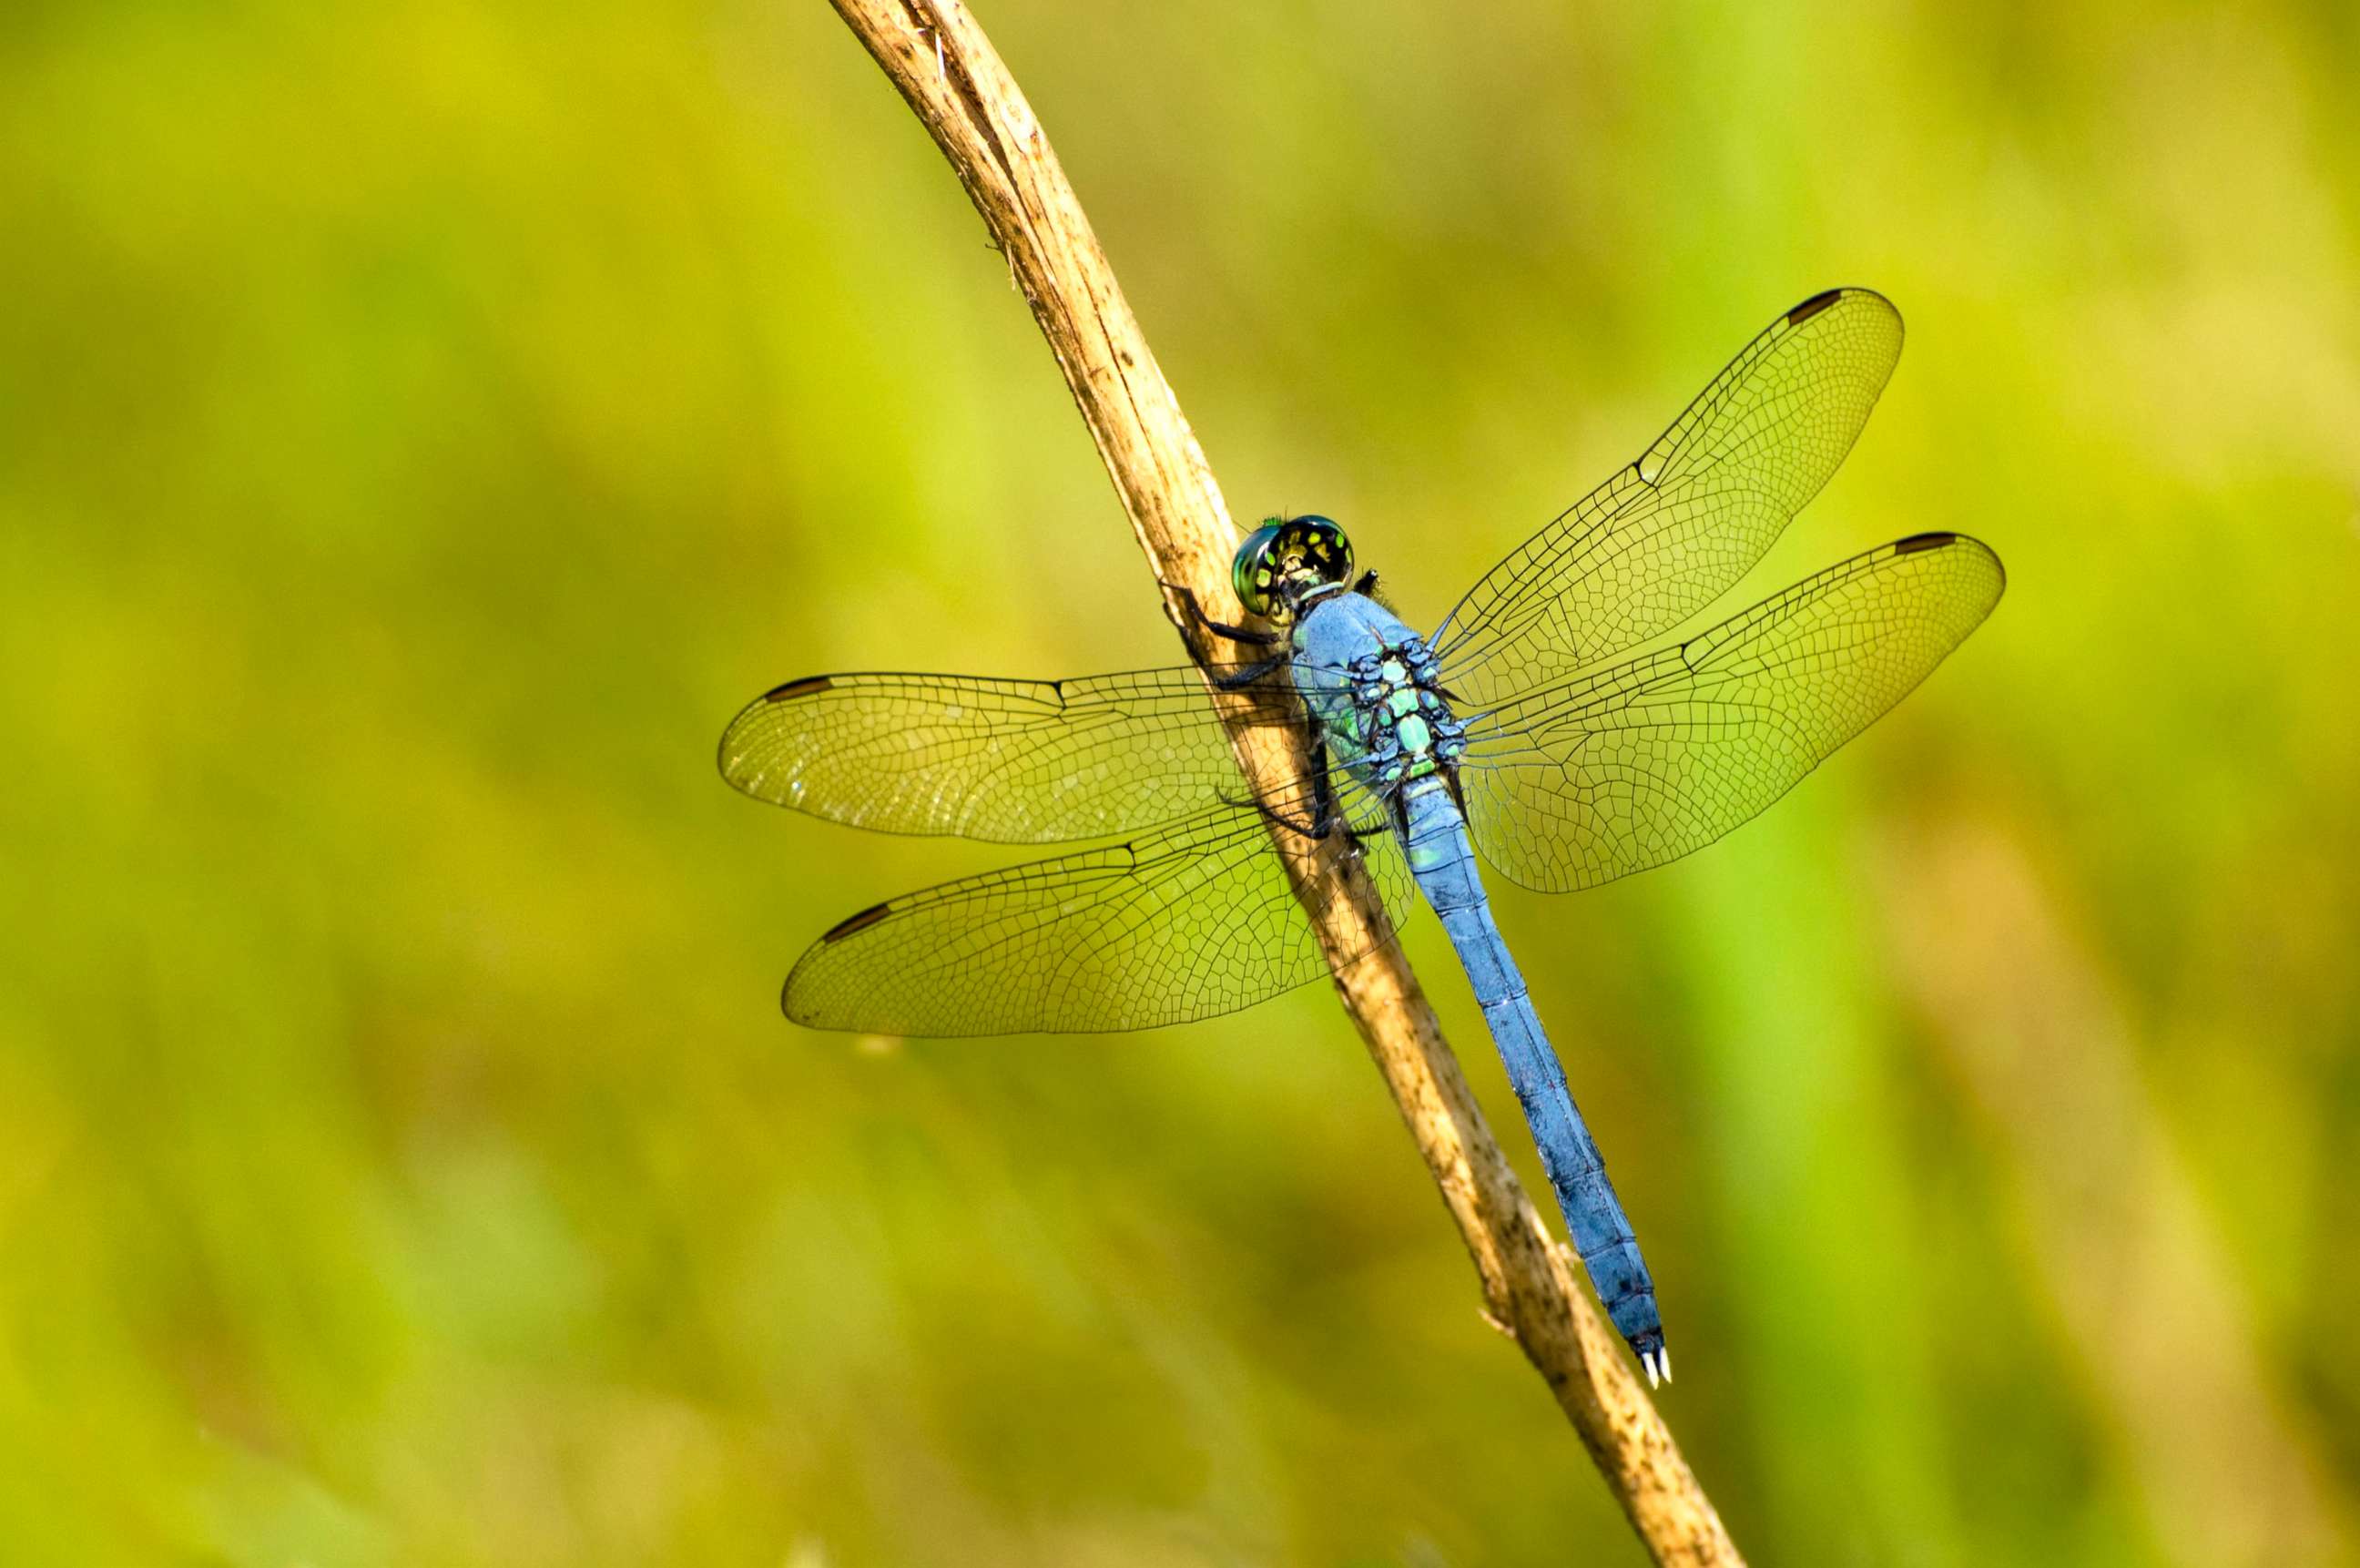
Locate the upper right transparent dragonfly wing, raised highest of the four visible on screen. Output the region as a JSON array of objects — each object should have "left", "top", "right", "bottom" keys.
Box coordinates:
[{"left": 1432, "top": 288, "right": 1902, "bottom": 706}]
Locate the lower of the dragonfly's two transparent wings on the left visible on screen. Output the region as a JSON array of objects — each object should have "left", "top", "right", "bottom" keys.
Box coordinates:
[{"left": 784, "top": 803, "right": 1411, "bottom": 1034}]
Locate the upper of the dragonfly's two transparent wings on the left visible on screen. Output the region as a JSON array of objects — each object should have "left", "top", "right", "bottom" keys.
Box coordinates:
[{"left": 720, "top": 666, "right": 1300, "bottom": 843}]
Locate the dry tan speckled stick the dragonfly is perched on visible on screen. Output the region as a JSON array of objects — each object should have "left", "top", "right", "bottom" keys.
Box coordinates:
[{"left": 830, "top": 0, "right": 1742, "bottom": 1563}]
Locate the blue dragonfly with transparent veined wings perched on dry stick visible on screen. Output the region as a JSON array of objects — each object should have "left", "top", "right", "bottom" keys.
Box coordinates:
[{"left": 720, "top": 288, "right": 2006, "bottom": 1384}]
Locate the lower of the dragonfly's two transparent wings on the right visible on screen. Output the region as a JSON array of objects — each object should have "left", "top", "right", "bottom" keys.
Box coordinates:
[{"left": 1459, "top": 534, "right": 2006, "bottom": 892}]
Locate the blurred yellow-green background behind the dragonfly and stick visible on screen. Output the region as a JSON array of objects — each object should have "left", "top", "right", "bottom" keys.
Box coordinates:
[{"left": 0, "top": 0, "right": 2360, "bottom": 1568}]
